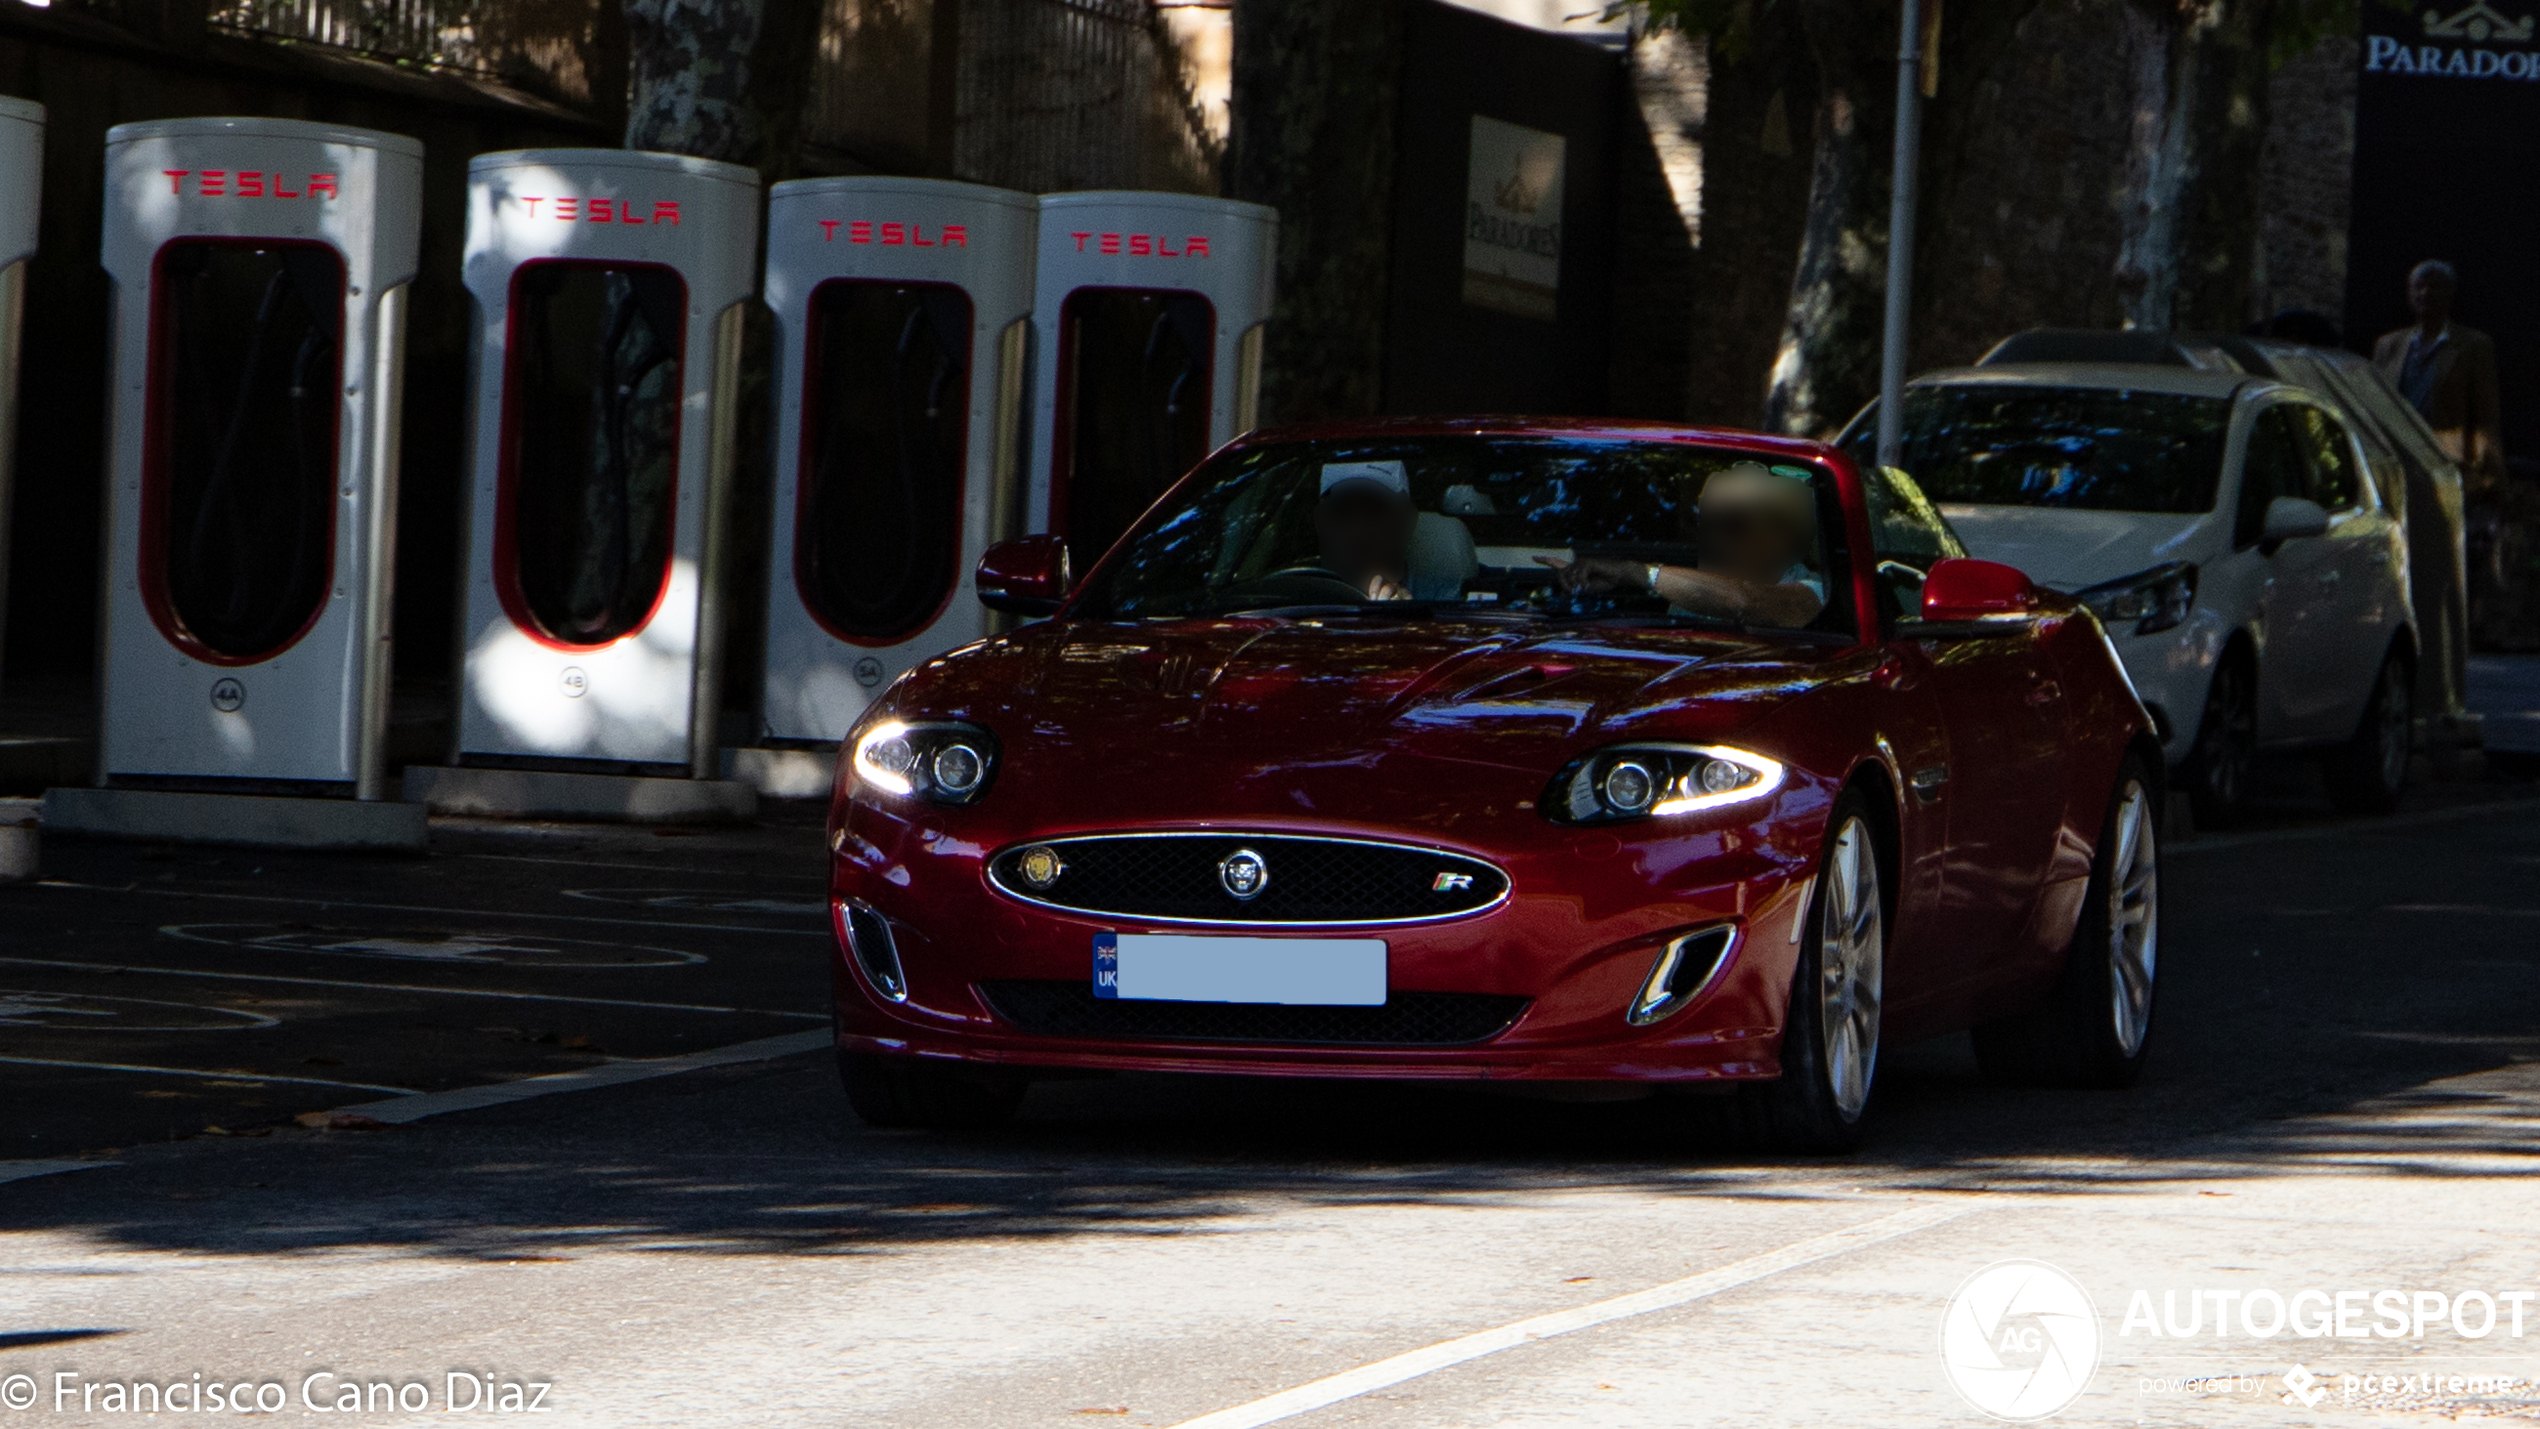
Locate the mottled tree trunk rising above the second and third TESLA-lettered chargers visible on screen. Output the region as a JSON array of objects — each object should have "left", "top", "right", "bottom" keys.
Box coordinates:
[{"left": 625, "top": 0, "right": 817, "bottom": 183}]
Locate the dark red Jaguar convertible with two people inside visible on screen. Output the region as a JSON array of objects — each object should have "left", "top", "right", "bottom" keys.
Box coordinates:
[{"left": 831, "top": 419, "right": 2162, "bottom": 1150}]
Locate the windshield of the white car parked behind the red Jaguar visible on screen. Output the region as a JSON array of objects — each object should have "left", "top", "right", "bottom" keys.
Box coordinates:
[{"left": 1847, "top": 383, "right": 2230, "bottom": 515}]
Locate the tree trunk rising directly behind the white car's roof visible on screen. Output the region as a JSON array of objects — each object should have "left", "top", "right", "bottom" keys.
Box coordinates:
[{"left": 2116, "top": 0, "right": 2273, "bottom": 333}]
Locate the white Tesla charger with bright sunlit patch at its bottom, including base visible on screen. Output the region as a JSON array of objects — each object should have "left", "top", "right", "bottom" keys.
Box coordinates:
[{"left": 406, "top": 150, "right": 759, "bottom": 817}]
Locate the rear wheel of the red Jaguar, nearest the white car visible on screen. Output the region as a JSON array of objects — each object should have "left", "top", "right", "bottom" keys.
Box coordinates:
[{"left": 1974, "top": 754, "right": 2162, "bottom": 1091}]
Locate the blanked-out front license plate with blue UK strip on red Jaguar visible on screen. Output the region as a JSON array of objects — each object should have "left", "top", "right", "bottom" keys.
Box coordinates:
[{"left": 1095, "top": 934, "right": 1384, "bottom": 1008}]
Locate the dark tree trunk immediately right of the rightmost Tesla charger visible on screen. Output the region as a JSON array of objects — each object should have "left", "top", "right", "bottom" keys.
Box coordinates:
[{"left": 1227, "top": 0, "right": 1405, "bottom": 421}]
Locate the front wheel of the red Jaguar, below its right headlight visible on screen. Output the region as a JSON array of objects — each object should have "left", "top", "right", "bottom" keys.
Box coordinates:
[{"left": 1740, "top": 789, "right": 1892, "bottom": 1155}]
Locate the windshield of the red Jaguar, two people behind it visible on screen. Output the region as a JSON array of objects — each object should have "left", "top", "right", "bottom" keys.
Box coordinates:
[{"left": 1077, "top": 437, "right": 1849, "bottom": 632}]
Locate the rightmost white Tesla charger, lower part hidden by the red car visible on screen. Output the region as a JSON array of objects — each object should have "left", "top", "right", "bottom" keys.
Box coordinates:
[{"left": 1031, "top": 193, "right": 1278, "bottom": 574}]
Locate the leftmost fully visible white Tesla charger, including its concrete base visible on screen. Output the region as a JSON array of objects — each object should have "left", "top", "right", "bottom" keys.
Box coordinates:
[{"left": 46, "top": 119, "right": 424, "bottom": 845}]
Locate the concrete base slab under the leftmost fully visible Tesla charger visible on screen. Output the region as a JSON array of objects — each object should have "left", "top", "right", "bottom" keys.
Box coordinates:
[{"left": 43, "top": 789, "right": 427, "bottom": 853}]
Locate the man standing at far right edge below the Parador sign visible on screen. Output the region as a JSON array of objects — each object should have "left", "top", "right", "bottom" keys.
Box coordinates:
[{"left": 2372, "top": 259, "right": 2540, "bottom": 650}]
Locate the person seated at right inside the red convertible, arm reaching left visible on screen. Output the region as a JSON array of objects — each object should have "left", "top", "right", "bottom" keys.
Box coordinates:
[{"left": 1537, "top": 462, "right": 1826, "bottom": 629}]
